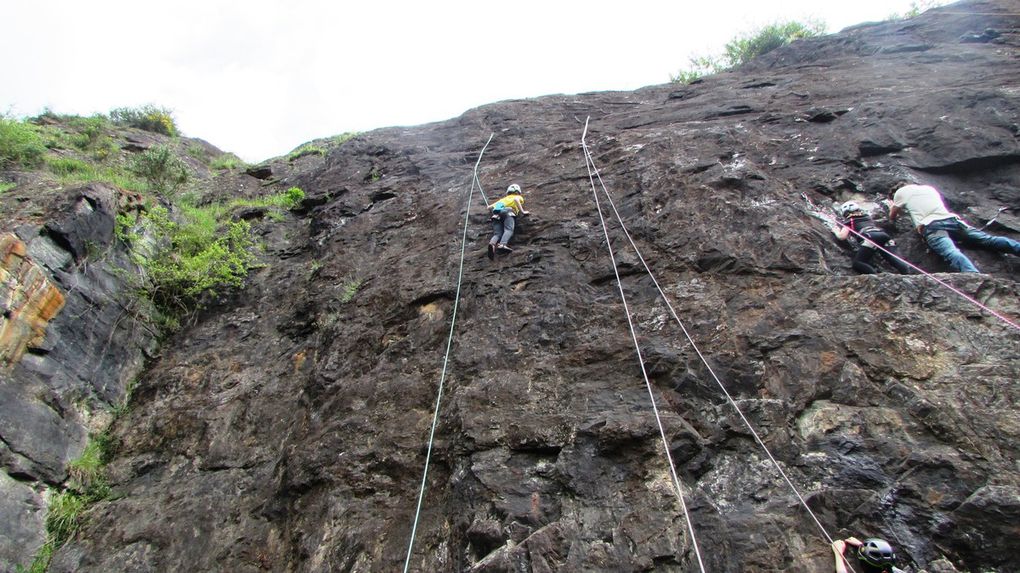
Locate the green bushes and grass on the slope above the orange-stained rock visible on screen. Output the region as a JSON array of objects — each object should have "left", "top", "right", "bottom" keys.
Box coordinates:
[{"left": 0, "top": 105, "right": 306, "bottom": 328}]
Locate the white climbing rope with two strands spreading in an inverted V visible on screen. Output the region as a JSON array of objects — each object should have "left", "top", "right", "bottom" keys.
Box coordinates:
[{"left": 581, "top": 120, "right": 853, "bottom": 571}]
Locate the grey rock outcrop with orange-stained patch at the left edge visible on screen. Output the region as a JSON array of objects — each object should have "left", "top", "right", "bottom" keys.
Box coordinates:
[{"left": 0, "top": 180, "right": 161, "bottom": 571}]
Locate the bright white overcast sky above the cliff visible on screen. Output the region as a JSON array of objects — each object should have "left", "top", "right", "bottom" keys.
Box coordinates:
[{"left": 0, "top": 0, "right": 938, "bottom": 162}]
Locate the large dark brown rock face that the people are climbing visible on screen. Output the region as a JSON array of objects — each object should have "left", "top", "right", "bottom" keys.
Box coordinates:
[{"left": 31, "top": 0, "right": 1020, "bottom": 572}]
